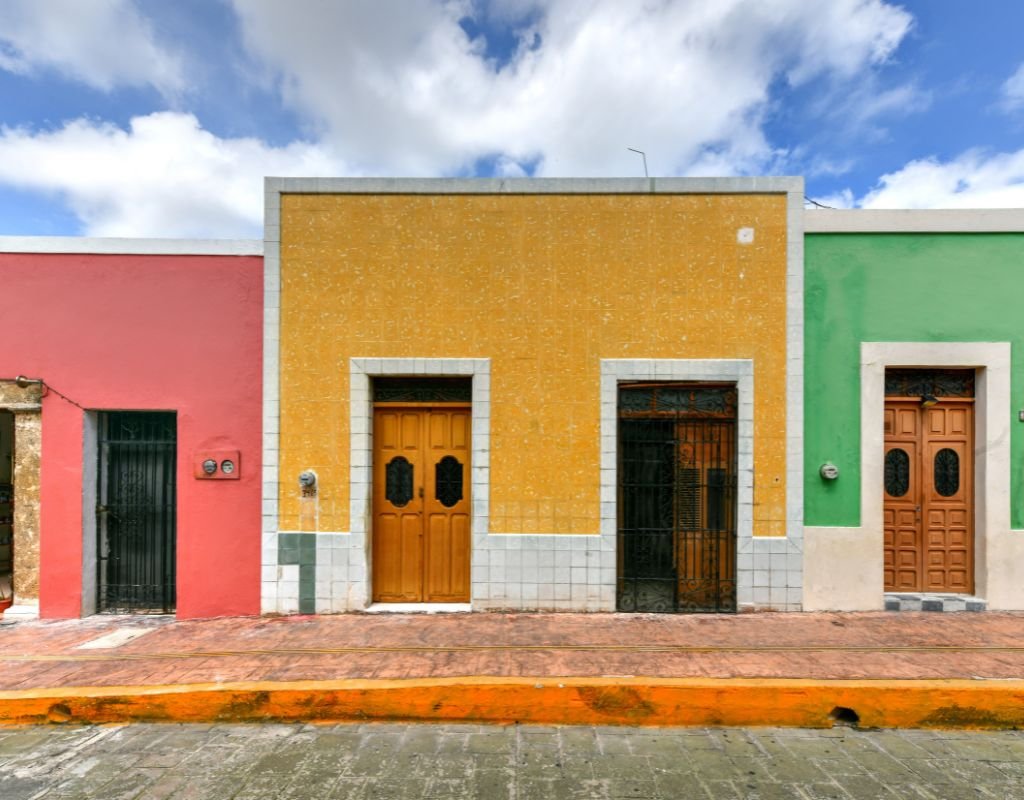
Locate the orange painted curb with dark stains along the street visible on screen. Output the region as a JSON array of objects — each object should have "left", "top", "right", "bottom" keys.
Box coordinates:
[{"left": 0, "top": 677, "right": 1024, "bottom": 728}]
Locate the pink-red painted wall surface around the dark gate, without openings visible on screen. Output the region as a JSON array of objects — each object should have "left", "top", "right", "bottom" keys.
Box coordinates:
[{"left": 0, "top": 253, "right": 262, "bottom": 618}]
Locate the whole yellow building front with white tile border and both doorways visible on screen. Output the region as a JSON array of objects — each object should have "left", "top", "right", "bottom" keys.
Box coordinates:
[{"left": 263, "top": 178, "right": 802, "bottom": 613}]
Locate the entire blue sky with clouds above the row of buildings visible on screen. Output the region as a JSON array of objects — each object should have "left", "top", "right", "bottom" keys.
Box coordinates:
[{"left": 0, "top": 0, "right": 1024, "bottom": 238}]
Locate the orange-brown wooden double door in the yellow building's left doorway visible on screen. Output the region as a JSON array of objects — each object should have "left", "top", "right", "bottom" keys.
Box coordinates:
[{"left": 372, "top": 405, "right": 471, "bottom": 602}]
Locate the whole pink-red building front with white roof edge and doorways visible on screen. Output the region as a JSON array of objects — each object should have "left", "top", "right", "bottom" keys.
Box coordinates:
[{"left": 0, "top": 238, "right": 263, "bottom": 618}]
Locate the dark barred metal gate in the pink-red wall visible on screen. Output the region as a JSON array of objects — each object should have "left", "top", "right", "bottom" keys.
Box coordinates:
[{"left": 96, "top": 411, "right": 177, "bottom": 614}]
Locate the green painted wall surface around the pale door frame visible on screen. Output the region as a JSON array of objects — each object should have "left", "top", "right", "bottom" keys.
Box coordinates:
[{"left": 804, "top": 234, "right": 1024, "bottom": 528}]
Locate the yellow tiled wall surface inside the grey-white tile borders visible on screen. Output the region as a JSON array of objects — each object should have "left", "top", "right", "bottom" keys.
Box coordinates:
[{"left": 280, "top": 194, "right": 786, "bottom": 536}]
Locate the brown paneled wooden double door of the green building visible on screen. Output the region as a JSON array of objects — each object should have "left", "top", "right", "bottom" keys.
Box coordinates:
[{"left": 884, "top": 397, "right": 974, "bottom": 594}]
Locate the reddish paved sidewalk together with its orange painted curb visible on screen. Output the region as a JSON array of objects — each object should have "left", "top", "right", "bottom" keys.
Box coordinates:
[{"left": 0, "top": 613, "right": 1024, "bottom": 727}]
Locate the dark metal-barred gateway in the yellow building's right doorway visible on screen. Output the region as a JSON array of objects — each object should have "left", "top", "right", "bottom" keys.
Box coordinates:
[{"left": 617, "top": 383, "right": 736, "bottom": 612}]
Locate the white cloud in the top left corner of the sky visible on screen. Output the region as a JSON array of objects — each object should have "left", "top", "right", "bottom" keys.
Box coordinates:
[{"left": 0, "top": 0, "right": 184, "bottom": 94}]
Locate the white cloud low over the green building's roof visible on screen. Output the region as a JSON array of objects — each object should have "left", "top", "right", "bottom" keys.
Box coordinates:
[{"left": 835, "top": 150, "right": 1024, "bottom": 208}]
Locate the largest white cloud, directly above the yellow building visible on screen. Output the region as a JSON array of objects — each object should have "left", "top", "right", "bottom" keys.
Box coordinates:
[{"left": 233, "top": 0, "right": 912, "bottom": 175}]
